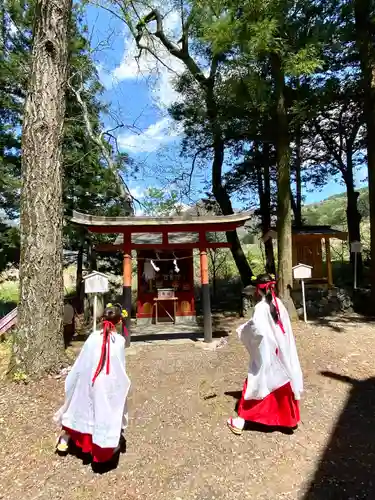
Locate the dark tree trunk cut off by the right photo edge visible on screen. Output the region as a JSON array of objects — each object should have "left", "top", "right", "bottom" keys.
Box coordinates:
[{"left": 354, "top": 0, "right": 375, "bottom": 301}]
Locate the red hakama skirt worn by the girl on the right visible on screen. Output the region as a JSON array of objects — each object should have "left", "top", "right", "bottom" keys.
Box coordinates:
[{"left": 237, "top": 379, "right": 300, "bottom": 428}]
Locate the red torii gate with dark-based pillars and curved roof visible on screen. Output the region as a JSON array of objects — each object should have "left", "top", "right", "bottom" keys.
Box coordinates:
[{"left": 71, "top": 211, "right": 251, "bottom": 345}]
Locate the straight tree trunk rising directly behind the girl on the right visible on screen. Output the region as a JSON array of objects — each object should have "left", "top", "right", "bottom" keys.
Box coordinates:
[{"left": 271, "top": 54, "right": 296, "bottom": 318}]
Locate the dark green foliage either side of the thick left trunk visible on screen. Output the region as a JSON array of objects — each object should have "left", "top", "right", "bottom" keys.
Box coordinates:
[{"left": 0, "top": 0, "right": 134, "bottom": 276}]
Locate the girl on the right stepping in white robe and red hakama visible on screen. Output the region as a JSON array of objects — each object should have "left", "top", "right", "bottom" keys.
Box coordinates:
[{"left": 227, "top": 275, "right": 303, "bottom": 434}]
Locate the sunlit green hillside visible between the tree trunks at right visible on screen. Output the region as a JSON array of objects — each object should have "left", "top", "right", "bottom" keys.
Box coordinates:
[{"left": 302, "top": 188, "right": 370, "bottom": 230}]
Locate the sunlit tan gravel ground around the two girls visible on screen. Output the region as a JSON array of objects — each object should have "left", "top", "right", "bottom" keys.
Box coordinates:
[{"left": 0, "top": 318, "right": 375, "bottom": 500}]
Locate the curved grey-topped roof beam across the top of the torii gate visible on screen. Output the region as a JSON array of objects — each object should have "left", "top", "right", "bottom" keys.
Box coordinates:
[{"left": 71, "top": 211, "right": 252, "bottom": 233}]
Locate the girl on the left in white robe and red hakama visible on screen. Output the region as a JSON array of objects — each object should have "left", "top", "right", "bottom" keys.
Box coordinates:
[{"left": 54, "top": 306, "right": 130, "bottom": 462}]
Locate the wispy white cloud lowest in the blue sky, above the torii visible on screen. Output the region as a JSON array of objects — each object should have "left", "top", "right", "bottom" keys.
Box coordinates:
[{"left": 118, "top": 117, "right": 180, "bottom": 153}]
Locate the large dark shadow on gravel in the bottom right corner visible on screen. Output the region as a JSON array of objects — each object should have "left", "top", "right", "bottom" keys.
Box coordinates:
[{"left": 303, "top": 372, "right": 375, "bottom": 500}]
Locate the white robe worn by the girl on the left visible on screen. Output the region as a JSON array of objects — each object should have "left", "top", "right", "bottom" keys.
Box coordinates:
[{"left": 54, "top": 331, "right": 130, "bottom": 448}]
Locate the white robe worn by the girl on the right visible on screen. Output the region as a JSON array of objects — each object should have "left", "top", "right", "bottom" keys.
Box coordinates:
[{"left": 237, "top": 298, "right": 303, "bottom": 400}]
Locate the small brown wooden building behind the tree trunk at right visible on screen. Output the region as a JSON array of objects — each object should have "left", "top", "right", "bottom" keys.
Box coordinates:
[{"left": 262, "top": 226, "right": 348, "bottom": 287}]
